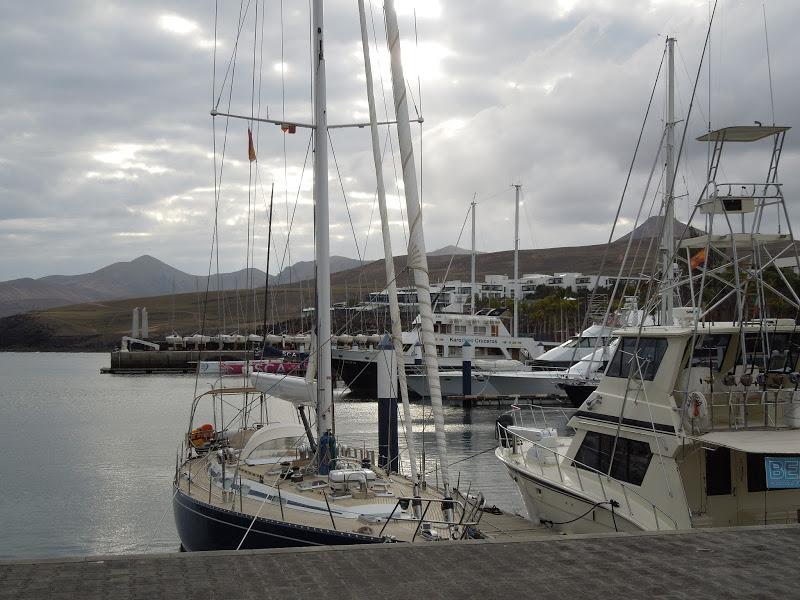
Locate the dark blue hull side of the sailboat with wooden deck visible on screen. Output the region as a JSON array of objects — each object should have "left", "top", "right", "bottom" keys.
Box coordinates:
[{"left": 172, "top": 490, "right": 385, "bottom": 552}]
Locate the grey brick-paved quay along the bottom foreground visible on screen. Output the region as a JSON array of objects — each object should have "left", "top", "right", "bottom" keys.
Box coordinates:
[{"left": 0, "top": 525, "right": 800, "bottom": 600}]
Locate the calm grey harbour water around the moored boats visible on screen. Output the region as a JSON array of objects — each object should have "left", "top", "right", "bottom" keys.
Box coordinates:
[{"left": 0, "top": 353, "right": 524, "bottom": 558}]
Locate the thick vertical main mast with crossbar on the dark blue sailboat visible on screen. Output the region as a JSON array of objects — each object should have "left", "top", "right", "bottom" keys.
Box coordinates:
[{"left": 312, "top": 0, "right": 333, "bottom": 437}]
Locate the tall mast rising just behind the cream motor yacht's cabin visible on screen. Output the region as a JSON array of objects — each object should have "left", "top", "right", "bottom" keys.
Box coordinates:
[{"left": 659, "top": 37, "right": 675, "bottom": 325}]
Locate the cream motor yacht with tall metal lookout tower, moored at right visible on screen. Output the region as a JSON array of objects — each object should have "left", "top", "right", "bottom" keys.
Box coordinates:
[{"left": 496, "top": 39, "right": 800, "bottom": 532}]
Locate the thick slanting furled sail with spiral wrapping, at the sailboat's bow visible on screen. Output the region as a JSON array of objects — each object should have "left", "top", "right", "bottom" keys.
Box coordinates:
[{"left": 384, "top": 0, "right": 450, "bottom": 496}]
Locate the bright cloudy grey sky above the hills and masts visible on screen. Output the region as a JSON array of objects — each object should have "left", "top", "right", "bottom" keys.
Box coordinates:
[{"left": 0, "top": 0, "right": 800, "bottom": 280}]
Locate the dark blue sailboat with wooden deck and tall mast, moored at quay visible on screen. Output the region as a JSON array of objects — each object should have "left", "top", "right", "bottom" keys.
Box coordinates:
[{"left": 173, "top": 0, "right": 483, "bottom": 550}]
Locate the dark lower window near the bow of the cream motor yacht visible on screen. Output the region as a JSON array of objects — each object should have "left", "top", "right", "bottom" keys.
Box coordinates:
[{"left": 573, "top": 431, "right": 653, "bottom": 485}]
